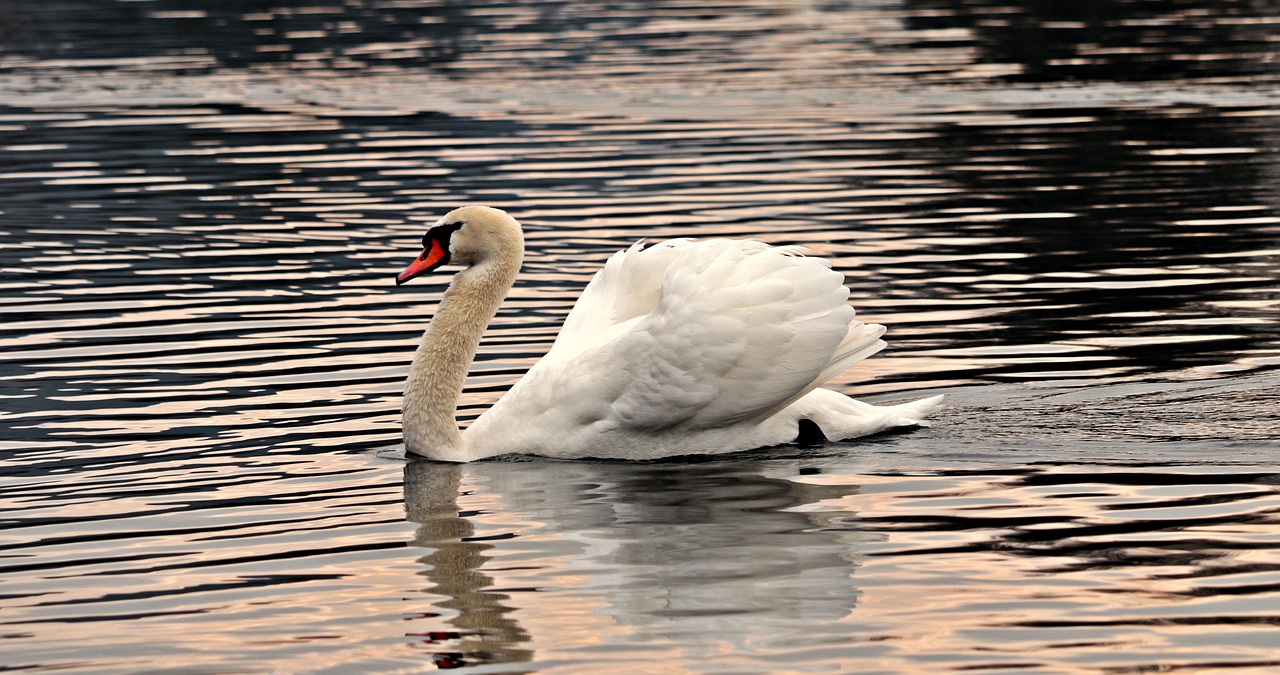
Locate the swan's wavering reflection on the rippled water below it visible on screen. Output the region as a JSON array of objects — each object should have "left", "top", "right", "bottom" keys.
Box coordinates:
[{"left": 404, "top": 460, "right": 881, "bottom": 663}]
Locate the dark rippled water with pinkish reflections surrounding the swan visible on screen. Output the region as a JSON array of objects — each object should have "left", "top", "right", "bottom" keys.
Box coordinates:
[{"left": 0, "top": 0, "right": 1280, "bottom": 672}]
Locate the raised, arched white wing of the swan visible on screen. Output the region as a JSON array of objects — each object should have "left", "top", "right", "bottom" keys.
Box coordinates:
[{"left": 537, "top": 240, "right": 884, "bottom": 430}]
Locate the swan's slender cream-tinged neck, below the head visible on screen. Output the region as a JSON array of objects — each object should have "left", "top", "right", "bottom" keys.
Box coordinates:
[{"left": 403, "top": 250, "right": 521, "bottom": 461}]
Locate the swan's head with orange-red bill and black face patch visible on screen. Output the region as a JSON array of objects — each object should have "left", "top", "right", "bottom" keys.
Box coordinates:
[{"left": 396, "top": 206, "right": 525, "bottom": 286}]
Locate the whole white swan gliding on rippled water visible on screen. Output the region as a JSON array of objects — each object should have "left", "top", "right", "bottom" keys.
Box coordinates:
[{"left": 396, "top": 206, "right": 942, "bottom": 462}]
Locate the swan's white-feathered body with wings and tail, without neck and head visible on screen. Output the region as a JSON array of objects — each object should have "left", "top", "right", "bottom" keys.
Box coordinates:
[{"left": 466, "top": 240, "right": 936, "bottom": 459}]
